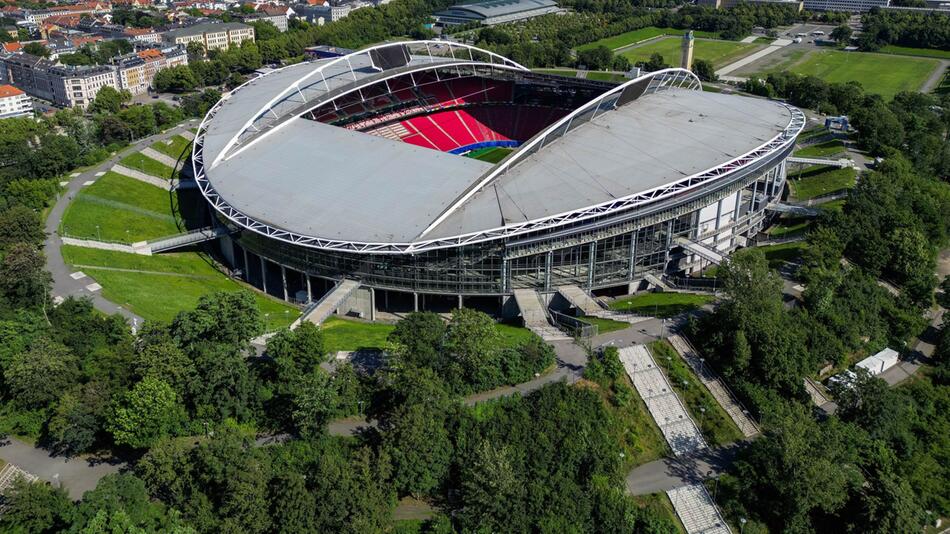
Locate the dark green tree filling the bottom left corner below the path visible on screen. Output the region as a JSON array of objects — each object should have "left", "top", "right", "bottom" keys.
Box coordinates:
[{"left": 0, "top": 478, "right": 73, "bottom": 532}]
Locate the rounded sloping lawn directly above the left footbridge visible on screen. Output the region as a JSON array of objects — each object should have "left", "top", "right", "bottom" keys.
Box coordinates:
[{"left": 61, "top": 171, "right": 180, "bottom": 243}]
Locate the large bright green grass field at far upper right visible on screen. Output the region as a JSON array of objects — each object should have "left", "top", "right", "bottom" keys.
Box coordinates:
[{"left": 788, "top": 46, "right": 939, "bottom": 99}]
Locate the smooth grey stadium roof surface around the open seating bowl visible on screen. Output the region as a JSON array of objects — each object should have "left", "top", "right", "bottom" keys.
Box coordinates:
[{"left": 202, "top": 42, "right": 800, "bottom": 253}]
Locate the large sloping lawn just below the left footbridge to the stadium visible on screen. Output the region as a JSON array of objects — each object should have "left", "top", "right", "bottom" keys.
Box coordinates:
[{"left": 62, "top": 245, "right": 300, "bottom": 330}]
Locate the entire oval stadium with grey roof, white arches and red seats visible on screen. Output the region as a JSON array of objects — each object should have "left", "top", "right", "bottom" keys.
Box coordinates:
[{"left": 192, "top": 41, "right": 804, "bottom": 316}]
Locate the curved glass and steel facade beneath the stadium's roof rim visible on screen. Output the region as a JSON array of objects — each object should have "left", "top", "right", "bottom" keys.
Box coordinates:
[{"left": 227, "top": 152, "right": 788, "bottom": 302}]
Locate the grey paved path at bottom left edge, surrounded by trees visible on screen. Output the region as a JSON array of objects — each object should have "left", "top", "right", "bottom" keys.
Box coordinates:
[{"left": 0, "top": 438, "right": 125, "bottom": 500}]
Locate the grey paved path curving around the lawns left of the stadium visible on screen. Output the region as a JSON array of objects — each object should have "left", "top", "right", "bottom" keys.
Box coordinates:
[{"left": 44, "top": 121, "right": 201, "bottom": 324}]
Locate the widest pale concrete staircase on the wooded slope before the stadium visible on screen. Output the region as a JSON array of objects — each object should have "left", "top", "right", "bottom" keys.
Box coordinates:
[{"left": 620, "top": 345, "right": 708, "bottom": 456}]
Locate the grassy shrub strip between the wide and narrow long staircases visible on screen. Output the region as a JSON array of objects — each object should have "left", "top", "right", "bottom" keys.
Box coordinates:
[{"left": 650, "top": 340, "right": 743, "bottom": 445}]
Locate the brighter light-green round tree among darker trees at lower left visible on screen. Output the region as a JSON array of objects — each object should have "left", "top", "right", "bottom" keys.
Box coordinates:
[{"left": 108, "top": 377, "right": 186, "bottom": 449}]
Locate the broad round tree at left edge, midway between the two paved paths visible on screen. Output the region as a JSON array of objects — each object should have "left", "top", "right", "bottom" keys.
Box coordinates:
[{"left": 4, "top": 337, "right": 79, "bottom": 409}]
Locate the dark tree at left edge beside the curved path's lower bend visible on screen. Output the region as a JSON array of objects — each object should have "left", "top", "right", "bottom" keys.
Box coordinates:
[{"left": 0, "top": 243, "right": 52, "bottom": 308}]
